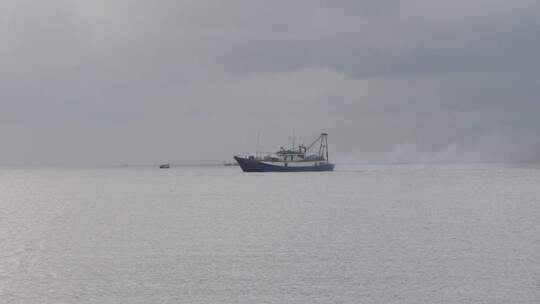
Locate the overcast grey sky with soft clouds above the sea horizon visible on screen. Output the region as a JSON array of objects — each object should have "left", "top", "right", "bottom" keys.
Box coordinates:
[{"left": 0, "top": 0, "right": 540, "bottom": 165}]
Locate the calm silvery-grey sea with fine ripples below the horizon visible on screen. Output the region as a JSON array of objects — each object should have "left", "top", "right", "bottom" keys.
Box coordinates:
[{"left": 0, "top": 164, "right": 540, "bottom": 304}]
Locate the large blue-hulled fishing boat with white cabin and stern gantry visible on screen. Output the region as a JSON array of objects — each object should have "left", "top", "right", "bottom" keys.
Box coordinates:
[{"left": 234, "top": 133, "right": 334, "bottom": 172}]
